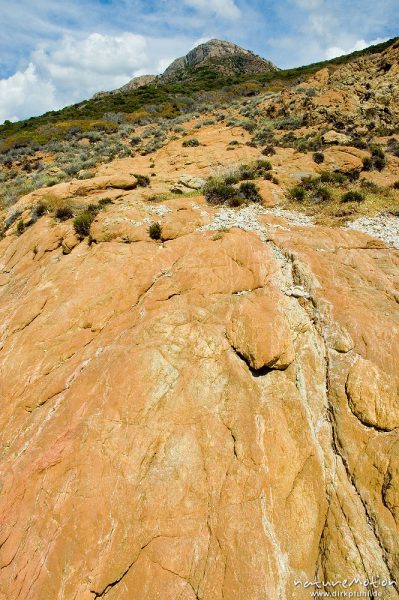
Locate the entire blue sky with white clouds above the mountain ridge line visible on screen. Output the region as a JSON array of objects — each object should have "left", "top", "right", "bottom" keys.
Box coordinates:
[{"left": 0, "top": 0, "right": 399, "bottom": 123}]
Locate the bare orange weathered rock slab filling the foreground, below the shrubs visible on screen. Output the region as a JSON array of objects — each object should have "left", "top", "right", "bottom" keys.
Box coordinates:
[{"left": 0, "top": 186, "right": 399, "bottom": 600}]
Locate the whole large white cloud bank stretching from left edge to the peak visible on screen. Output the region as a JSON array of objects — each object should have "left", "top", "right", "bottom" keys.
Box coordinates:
[{"left": 0, "top": 33, "right": 189, "bottom": 123}]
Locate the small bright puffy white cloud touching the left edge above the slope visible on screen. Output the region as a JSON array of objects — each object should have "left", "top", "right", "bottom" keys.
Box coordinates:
[{"left": 0, "top": 63, "right": 60, "bottom": 123}]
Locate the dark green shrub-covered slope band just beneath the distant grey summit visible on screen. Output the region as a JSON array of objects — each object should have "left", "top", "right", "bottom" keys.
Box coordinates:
[{"left": 0, "top": 38, "right": 396, "bottom": 151}]
